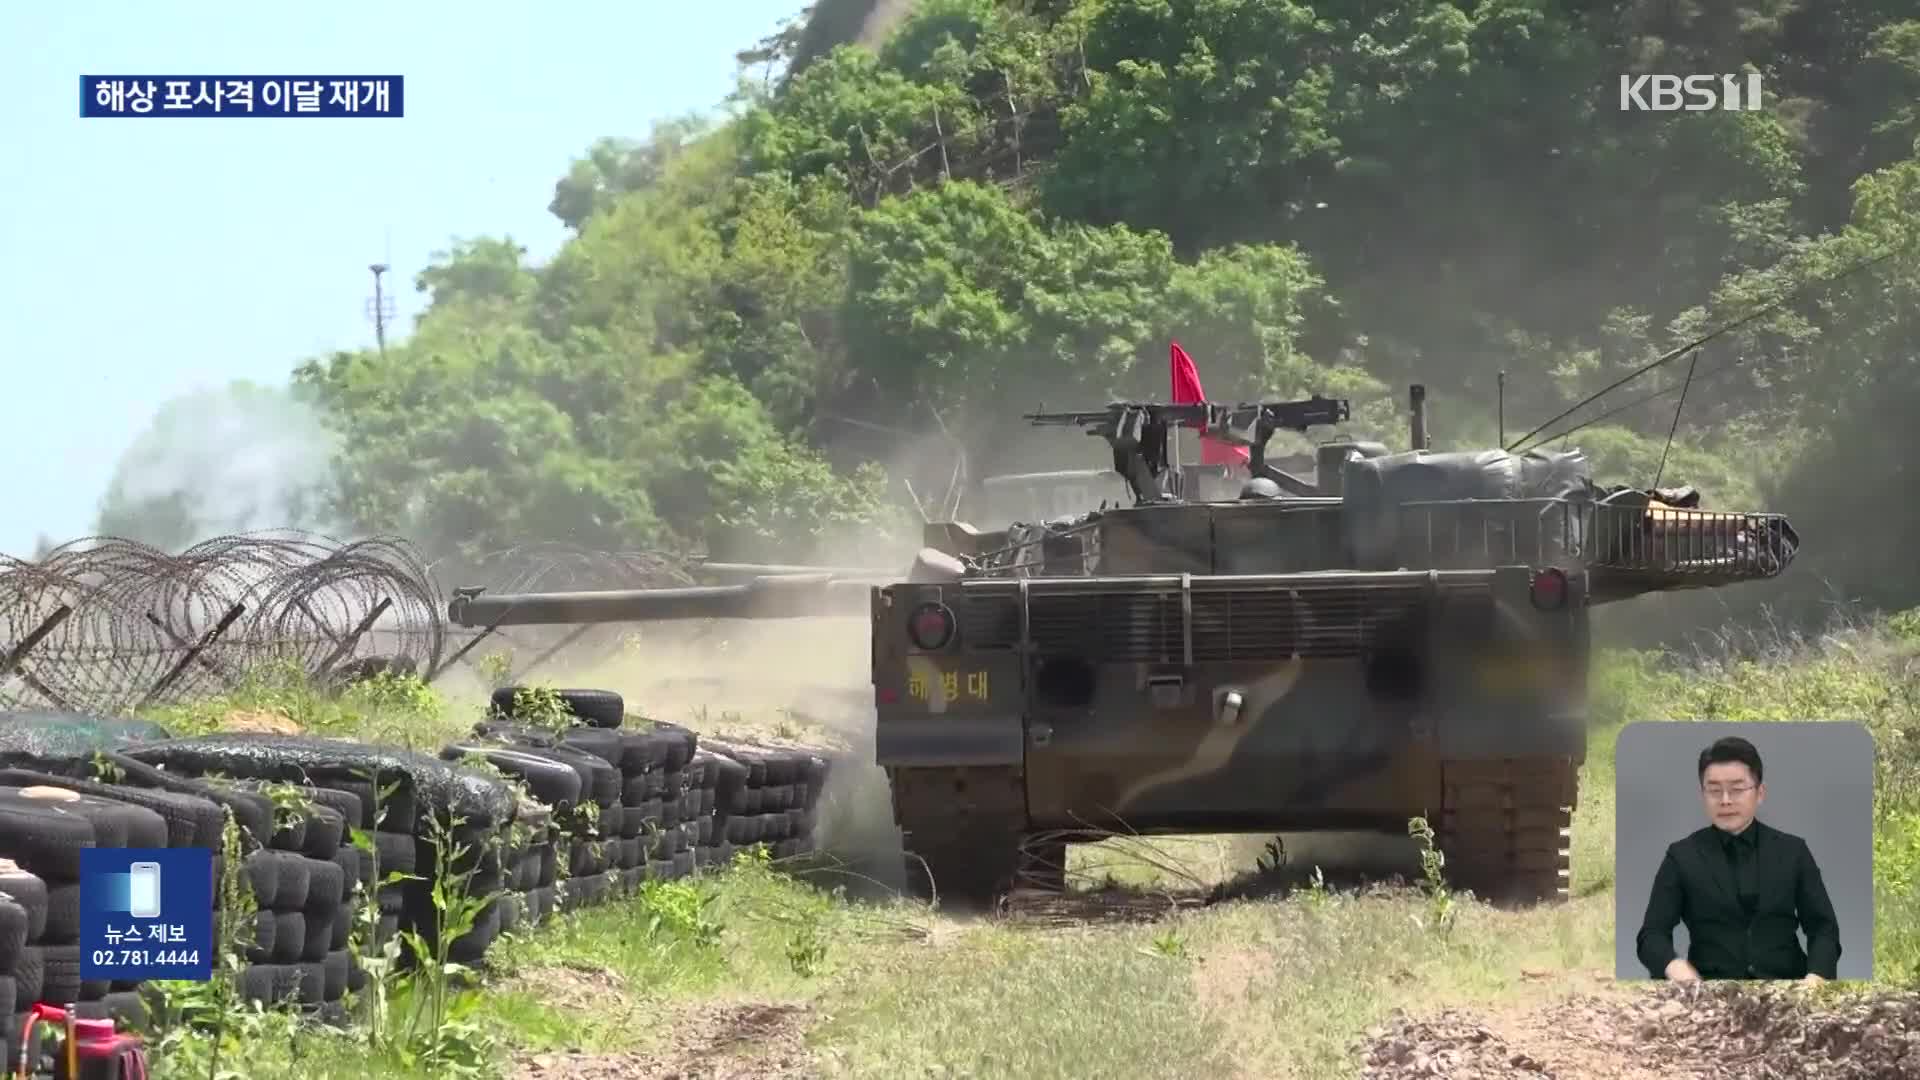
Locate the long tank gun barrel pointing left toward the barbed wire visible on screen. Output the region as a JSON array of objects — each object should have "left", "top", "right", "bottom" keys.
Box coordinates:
[{"left": 447, "top": 575, "right": 874, "bottom": 626}]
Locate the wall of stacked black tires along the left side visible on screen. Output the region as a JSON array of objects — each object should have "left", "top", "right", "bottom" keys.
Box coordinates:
[{"left": 0, "top": 688, "right": 848, "bottom": 1040}]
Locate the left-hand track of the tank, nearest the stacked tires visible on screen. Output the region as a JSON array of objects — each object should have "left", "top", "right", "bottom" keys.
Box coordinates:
[{"left": 887, "top": 767, "right": 1066, "bottom": 911}]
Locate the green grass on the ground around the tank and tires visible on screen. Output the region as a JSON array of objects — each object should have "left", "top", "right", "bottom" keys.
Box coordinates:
[{"left": 123, "top": 619, "right": 1920, "bottom": 1080}]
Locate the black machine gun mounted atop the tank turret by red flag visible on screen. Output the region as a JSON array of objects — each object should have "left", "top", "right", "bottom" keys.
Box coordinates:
[{"left": 1023, "top": 394, "right": 1352, "bottom": 503}]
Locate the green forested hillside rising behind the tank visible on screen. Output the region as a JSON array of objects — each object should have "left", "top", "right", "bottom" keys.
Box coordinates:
[{"left": 101, "top": 0, "right": 1920, "bottom": 618}]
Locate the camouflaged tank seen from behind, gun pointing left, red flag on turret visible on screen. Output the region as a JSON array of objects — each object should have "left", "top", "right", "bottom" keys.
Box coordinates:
[{"left": 451, "top": 388, "right": 1799, "bottom": 905}]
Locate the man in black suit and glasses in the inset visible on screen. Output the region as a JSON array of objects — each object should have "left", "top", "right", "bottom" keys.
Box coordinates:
[{"left": 1636, "top": 738, "right": 1839, "bottom": 984}]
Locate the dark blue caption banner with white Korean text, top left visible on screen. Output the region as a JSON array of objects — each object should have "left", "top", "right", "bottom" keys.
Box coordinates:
[{"left": 81, "top": 75, "right": 407, "bottom": 119}]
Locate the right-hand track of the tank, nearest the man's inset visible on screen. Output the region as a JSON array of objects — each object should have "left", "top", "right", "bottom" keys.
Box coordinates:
[{"left": 1434, "top": 757, "right": 1578, "bottom": 905}]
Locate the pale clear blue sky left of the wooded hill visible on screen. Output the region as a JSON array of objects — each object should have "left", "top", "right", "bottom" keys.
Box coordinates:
[{"left": 0, "top": 0, "right": 804, "bottom": 555}]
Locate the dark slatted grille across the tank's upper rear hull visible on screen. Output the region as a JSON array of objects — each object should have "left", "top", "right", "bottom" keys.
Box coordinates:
[{"left": 962, "top": 584, "right": 1492, "bottom": 663}]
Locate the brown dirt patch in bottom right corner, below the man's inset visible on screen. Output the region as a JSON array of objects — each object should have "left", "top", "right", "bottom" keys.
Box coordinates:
[{"left": 1359, "top": 984, "right": 1920, "bottom": 1080}]
